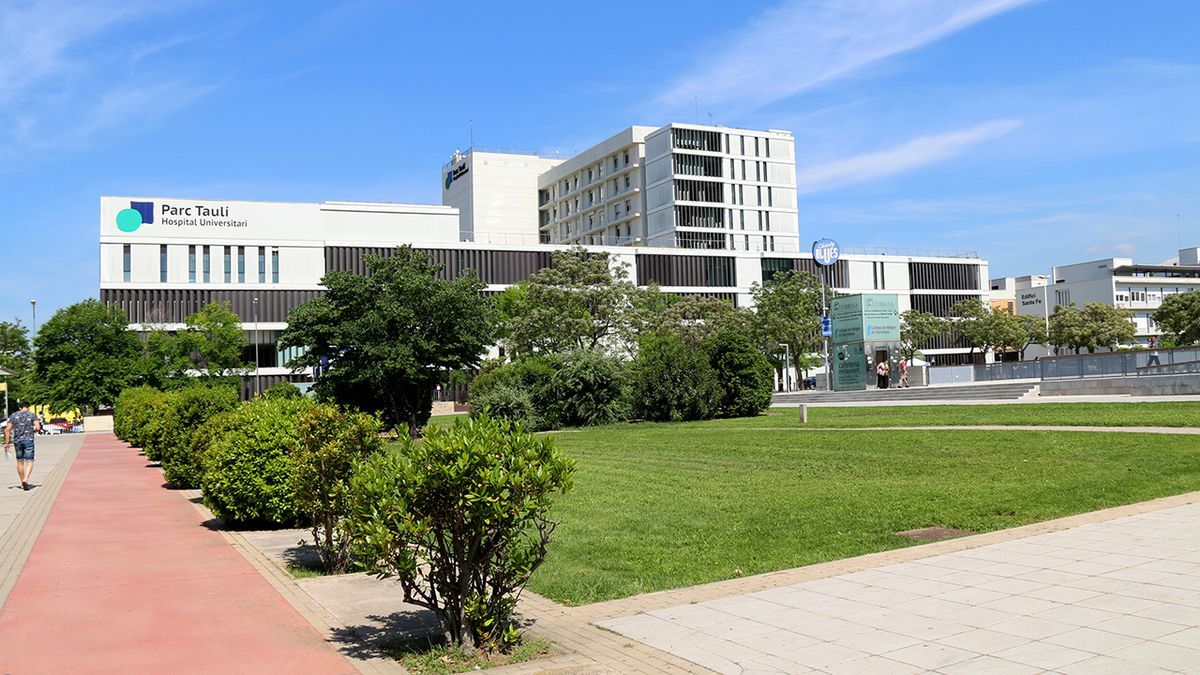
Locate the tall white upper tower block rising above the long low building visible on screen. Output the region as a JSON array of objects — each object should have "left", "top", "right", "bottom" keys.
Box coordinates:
[{"left": 442, "top": 124, "right": 800, "bottom": 252}]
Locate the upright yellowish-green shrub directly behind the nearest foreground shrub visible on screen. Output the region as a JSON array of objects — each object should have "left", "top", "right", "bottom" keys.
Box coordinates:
[{"left": 292, "top": 405, "right": 383, "bottom": 573}]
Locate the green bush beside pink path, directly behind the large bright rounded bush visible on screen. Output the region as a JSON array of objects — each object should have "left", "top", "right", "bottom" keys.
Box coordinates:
[{"left": 162, "top": 386, "right": 238, "bottom": 488}]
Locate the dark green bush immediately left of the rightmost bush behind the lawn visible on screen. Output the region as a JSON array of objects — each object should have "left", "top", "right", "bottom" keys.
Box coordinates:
[{"left": 630, "top": 334, "right": 721, "bottom": 422}]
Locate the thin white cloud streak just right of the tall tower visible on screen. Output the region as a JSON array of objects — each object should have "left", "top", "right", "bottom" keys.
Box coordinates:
[{"left": 796, "top": 120, "right": 1020, "bottom": 193}]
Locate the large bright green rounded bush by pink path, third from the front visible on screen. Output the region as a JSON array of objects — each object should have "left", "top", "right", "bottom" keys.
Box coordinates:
[{"left": 200, "top": 398, "right": 313, "bottom": 525}]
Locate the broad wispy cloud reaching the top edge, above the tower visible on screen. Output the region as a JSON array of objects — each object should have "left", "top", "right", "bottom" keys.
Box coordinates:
[{"left": 658, "top": 0, "right": 1031, "bottom": 109}]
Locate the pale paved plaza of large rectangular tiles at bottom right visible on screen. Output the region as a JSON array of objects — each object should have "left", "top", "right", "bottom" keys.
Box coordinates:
[{"left": 601, "top": 504, "right": 1200, "bottom": 674}]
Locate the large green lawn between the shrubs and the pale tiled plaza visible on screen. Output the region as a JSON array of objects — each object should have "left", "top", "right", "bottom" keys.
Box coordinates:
[{"left": 530, "top": 417, "right": 1200, "bottom": 604}]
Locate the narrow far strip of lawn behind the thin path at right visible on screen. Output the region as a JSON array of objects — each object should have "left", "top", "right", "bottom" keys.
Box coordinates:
[{"left": 722, "top": 401, "right": 1200, "bottom": 428}]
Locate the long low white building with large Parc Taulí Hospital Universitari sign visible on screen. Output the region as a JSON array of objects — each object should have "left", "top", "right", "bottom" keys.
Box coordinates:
[{"left": 100, "top": 197, "right": 988, "bottom": 387}]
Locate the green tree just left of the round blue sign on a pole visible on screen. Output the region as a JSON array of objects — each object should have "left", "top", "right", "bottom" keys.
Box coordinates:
[{"left": 750, "top": 270, "right": 822, "bottom": 379}]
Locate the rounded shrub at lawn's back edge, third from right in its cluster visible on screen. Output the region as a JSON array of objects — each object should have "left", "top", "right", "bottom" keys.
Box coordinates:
[{"left": 541, "top": 350, "right": 626, "bottom": 428}]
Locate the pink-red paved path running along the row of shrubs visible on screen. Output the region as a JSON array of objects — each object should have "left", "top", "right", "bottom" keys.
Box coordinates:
[{"left": 0, "top": 434, "right": 355, "bottom": 673}]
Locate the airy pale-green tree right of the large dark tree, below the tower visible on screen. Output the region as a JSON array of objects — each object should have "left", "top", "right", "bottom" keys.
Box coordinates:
[{"left": 500, "top": 246, "right": 636, "bottom": 356}]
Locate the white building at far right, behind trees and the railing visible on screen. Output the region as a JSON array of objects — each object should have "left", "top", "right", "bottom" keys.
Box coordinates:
[{"left": 1016, "top": 247, "right": 1200, "bottom": 345}]
